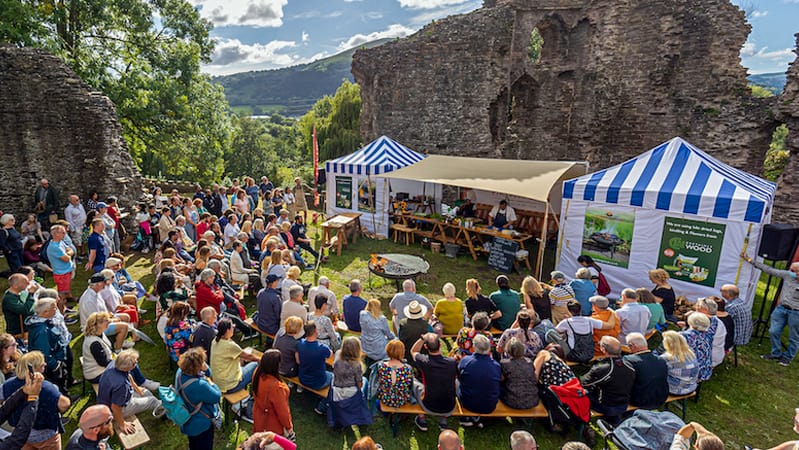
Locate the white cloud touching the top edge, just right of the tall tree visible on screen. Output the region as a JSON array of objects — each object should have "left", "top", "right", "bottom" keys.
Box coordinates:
[{"left": 191, "top": 0, "right": 288, "bottom": 27}]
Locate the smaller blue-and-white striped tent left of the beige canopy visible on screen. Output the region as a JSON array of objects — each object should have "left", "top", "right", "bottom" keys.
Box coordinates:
[{"left": 325, "top": 136, "right": 432, "bottom": 236}]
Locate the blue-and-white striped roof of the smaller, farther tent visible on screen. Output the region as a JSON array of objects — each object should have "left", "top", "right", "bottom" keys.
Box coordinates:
[{"left": 325, "top": 136, "right": 424, "bottom": 175}]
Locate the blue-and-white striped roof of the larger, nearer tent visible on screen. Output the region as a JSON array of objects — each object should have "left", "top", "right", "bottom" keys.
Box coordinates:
[{"left": 563, "top": 137, "right": 777, "bottom": 223}]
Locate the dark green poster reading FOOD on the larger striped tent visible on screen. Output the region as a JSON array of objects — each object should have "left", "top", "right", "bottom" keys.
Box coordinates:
[{"left": 658, "top": 216, "right": 727, "bottom": 287}]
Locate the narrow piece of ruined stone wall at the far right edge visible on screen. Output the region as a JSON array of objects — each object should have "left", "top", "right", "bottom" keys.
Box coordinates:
[{"left": 774, "top": 33, "right": 799, "bottom": 224}]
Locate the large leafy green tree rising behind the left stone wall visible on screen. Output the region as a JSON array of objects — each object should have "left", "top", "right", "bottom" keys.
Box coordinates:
[{"left": 0, "top": 0, "right": 232, "bottom": 181}]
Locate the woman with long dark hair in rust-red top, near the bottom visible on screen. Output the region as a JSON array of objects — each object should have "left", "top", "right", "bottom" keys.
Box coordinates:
[{"left": 252, "top": 349, "right": 294, "bottom": 439}]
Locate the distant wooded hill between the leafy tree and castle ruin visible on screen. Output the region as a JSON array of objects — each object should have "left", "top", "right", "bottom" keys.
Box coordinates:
[{"left": 213, "top": 39, "right": 391, "bottom": 117}]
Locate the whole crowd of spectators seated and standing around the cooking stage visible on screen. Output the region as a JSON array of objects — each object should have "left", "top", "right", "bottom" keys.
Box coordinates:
[{"left": 0, "top": 177, "right": 799, "bottom": 450}]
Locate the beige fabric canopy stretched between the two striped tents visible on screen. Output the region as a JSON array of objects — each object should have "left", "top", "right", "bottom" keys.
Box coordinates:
[{"left": 379, "top": 155, "right": 588, "bottom": 203}]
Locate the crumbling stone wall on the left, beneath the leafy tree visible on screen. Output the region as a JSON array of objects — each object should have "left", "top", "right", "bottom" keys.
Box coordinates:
[{"left": 0, "top": 46, "right": 142, "bottom": 219}]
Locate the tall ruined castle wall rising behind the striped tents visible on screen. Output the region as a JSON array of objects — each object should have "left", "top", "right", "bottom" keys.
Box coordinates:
[{"left": 352, "top": 0, "right": 799, "bottom": 221}]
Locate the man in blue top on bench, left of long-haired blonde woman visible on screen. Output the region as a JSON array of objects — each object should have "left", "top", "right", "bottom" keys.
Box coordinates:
[{"left": 297, "top": 320, "right": 333, "bottom": 415}]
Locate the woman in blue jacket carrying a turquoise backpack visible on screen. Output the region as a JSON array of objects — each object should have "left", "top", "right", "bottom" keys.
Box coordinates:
[{"left": 175, "top": 347, "right": 222, "bottom": 450}]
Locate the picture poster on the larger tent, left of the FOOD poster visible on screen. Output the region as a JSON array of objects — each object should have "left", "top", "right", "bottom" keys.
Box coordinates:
[{"left": 582, "top": 206, "right": 635, "bottom": 269}]
